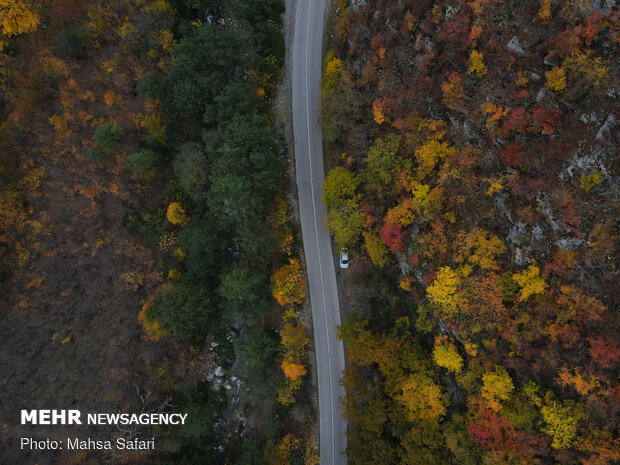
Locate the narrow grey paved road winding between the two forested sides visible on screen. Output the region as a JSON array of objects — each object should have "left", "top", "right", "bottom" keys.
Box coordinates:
[{"left": 292, "top": 0, "right": 346, "bottom": 465}]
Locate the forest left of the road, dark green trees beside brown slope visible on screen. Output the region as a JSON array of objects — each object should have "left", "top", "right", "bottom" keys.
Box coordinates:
[{"left": 0, "top": 0, "right": 318, "bottom": 465}]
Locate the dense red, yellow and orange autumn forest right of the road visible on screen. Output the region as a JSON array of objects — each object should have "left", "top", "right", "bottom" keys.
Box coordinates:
[{"left": 321, "top": 0, "right": 620, "bottom": 465}]
